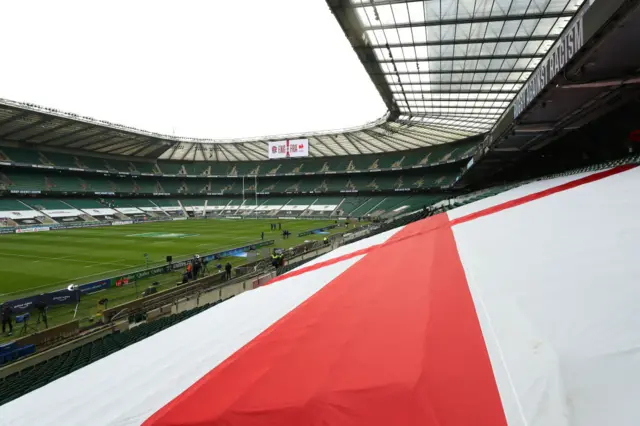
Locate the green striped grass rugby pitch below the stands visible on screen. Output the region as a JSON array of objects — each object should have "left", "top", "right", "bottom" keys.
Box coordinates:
[{"left": 0, "top": 219, "right": 340, "bottom": 300}]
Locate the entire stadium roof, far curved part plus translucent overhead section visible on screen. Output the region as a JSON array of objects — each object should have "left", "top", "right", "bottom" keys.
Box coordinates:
[{"left": 0, "top": 0, "right": 584, "bottom": 161}]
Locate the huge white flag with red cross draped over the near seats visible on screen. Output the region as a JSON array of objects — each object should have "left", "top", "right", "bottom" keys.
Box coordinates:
[{"left": 0, "top": 167, "right": 640, "bottom": 426}]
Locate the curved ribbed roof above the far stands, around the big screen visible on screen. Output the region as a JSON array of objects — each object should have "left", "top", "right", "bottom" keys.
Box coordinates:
[{"left": 0, "top": 99, "right": 483, "bottom": 161}]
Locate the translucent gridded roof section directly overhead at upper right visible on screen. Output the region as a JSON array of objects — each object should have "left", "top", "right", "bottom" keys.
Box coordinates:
[{"left": 350, "top": 0, "right": 584, "bottom": 132}]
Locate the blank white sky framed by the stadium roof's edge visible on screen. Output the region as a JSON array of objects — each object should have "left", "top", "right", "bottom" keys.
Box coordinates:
[{"left": 0, "top": 0, "right": 386, "bottom": 138}]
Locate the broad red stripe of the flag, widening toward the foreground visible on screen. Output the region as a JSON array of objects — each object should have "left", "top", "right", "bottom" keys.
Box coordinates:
[{"left": 144, "top": 215, "right": 506, "bottom": 426}]
